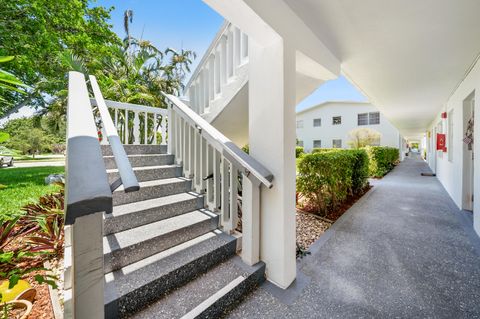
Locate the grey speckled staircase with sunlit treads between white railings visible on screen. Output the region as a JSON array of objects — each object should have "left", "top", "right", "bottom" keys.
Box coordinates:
[{"left": 102, "top": 145, "right": 265, "bottom": 318}]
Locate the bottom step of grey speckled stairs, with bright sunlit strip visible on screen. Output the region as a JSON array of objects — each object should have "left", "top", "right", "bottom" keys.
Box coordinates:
[{"left": 130, "top": 256, "right": 265, "bottom": 319}]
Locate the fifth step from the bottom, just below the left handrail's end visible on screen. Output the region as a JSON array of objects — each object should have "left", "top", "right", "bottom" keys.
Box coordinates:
[{"left": 113, "top": 177, "right": 192, "bottom": 206}]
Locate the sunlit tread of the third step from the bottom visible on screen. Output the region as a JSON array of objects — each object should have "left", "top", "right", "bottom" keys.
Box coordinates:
[{"left": 103, "top": 209, "right": 217, "bottom": 254}]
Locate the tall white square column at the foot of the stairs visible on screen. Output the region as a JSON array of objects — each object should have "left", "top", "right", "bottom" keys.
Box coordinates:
[{"left": 248, "top": 37, "right": 296, "bottom": 288}]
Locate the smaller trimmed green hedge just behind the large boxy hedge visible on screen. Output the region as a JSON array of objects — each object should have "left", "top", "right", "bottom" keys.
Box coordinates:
[{"left": 364, "top": 146, "right": 399, "bottom": 177}]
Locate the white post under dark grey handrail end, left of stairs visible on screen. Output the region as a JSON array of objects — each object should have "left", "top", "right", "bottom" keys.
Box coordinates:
[{"left": 72, "top": 212, "right": 104, "bottom": 319}]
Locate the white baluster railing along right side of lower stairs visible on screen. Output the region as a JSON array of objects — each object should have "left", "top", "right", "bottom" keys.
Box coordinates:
[{"left": 165, "top": 95, "right": 273, "bottom": 265}]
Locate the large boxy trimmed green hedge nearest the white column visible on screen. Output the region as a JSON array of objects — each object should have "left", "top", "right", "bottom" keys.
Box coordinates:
[{"left": 297, "top": 149, "right": 368, "bottom": 214}]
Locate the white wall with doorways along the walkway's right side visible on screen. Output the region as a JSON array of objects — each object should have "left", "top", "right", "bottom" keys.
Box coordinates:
[{"left": 427, "top": 58, "right": 480, "bottom": 235}]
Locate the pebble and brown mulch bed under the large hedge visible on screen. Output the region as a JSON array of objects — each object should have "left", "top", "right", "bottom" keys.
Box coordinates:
[{"left": 296, "top": 185, "right": 372, "bottom": 250}]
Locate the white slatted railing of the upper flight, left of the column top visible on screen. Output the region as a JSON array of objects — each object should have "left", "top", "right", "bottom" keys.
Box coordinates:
[{"left": 185, "top": 22, "right": 248, "bottom": 115}]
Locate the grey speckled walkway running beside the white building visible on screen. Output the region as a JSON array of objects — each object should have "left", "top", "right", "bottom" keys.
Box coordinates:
[{"left": 229, "top": 154, "right": 480, "bottom": 318}]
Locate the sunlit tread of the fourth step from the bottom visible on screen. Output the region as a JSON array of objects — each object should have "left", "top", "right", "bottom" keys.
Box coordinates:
[{"left": 105, "top": 192, "right": 202, "bottom": 218}]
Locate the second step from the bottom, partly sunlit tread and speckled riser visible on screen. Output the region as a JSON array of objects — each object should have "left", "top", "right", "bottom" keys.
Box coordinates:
[{"left": 105, "top": 230, "right": 236, "bottom": 318}]
